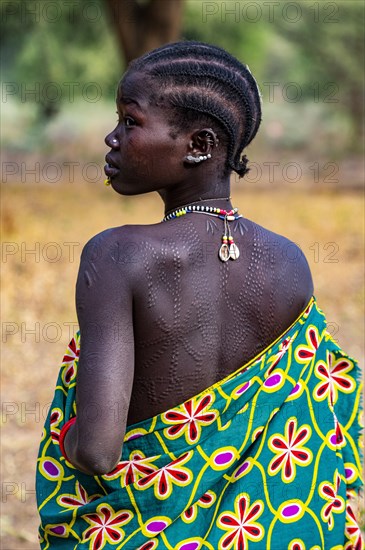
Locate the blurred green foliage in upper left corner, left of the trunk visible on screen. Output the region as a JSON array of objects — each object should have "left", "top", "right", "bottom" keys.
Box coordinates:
[{"left": 0, "top": 0, "right": 122, "bottom": 117}]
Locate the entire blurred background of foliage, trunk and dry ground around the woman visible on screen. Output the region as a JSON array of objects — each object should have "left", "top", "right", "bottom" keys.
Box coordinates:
[{"left": 0, "top": 0, "right": 364, "bottom": 550}]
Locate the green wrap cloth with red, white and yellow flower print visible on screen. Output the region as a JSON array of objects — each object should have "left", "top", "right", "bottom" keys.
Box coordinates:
[{"left": 37, "top": 298, "right": 364, "bottom": 550}]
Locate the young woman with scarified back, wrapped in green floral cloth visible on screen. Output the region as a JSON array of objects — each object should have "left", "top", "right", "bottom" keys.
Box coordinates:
[{"left": 37, "top": 42, "right": 362, "bottom": 550}]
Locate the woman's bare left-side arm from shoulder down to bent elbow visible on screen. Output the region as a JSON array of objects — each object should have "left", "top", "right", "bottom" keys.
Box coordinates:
[{"left": 71, "top": 230, "right": 134, "bottom": 473}]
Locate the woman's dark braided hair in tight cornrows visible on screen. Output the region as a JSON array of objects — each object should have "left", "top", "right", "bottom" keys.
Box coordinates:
[{"left": 127, "top": 41, "right": 261, "bottom": 177}]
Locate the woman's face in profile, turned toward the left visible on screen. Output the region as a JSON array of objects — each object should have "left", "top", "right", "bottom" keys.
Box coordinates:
[{"left": 105, "top": 72, "right": 189, "bottom": 195}]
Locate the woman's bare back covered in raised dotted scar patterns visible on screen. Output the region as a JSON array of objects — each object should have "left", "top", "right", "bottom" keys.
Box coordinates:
[{"left": 105, "top": 215, "right": 313, "bottom": 424}]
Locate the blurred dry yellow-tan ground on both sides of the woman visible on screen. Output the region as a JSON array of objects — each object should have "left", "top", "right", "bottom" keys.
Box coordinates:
[{"left": 1, "top": 184, "right": 364, "bottom": 550}]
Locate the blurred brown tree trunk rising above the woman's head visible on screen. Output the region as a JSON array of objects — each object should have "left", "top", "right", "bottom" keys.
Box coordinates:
[{"left": 106, "top": 0, "right": 184, "bottom": 63}]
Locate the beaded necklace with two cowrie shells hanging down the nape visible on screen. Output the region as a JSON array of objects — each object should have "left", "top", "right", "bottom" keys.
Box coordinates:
[{"left": 162, "top": 204, "right": 242, "bottom": 262}]
